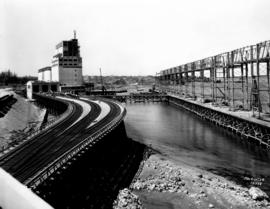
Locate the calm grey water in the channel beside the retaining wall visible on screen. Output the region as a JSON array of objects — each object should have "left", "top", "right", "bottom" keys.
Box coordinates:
[{"left": 126, "top": 103, "right": 270, "bottom": 193}]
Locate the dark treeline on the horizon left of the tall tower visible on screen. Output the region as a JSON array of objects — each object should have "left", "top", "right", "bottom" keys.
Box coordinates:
[{"left": 0, "top": 70, "right": 37, "bottom": 86}]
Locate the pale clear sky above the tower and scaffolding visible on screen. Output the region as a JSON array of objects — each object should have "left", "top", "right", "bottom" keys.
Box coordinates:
[{"left": 0, "top": 0, "right": 270, "bottom": 76}]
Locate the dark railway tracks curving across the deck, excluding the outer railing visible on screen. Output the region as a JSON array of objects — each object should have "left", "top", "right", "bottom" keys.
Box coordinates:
[{"left": 0, "top": 95, "right": 121, "bottom": 186}]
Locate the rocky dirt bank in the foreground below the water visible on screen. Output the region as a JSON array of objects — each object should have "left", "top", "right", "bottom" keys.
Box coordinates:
[{"left": 114, "top": 154, "right": 270, "bottom": 209}]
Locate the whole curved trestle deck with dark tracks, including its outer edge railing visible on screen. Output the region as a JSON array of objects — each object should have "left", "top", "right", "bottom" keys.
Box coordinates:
[{"left": 0, "top": 94, "right": 126, "bottom": 188}]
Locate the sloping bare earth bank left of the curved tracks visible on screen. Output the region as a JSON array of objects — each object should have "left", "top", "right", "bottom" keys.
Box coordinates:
[{"left": 0, "top": 90, "right": 45, "bottom": 148}]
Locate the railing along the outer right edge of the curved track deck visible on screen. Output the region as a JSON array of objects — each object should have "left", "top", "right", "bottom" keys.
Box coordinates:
[{"left": 25, "top": 105, "right": 126, "bottom": 188}]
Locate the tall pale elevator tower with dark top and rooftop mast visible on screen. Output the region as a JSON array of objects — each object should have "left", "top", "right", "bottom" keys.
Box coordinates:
[{"left": 51, "top": 32, "right": 83, "bottom": 87}]
